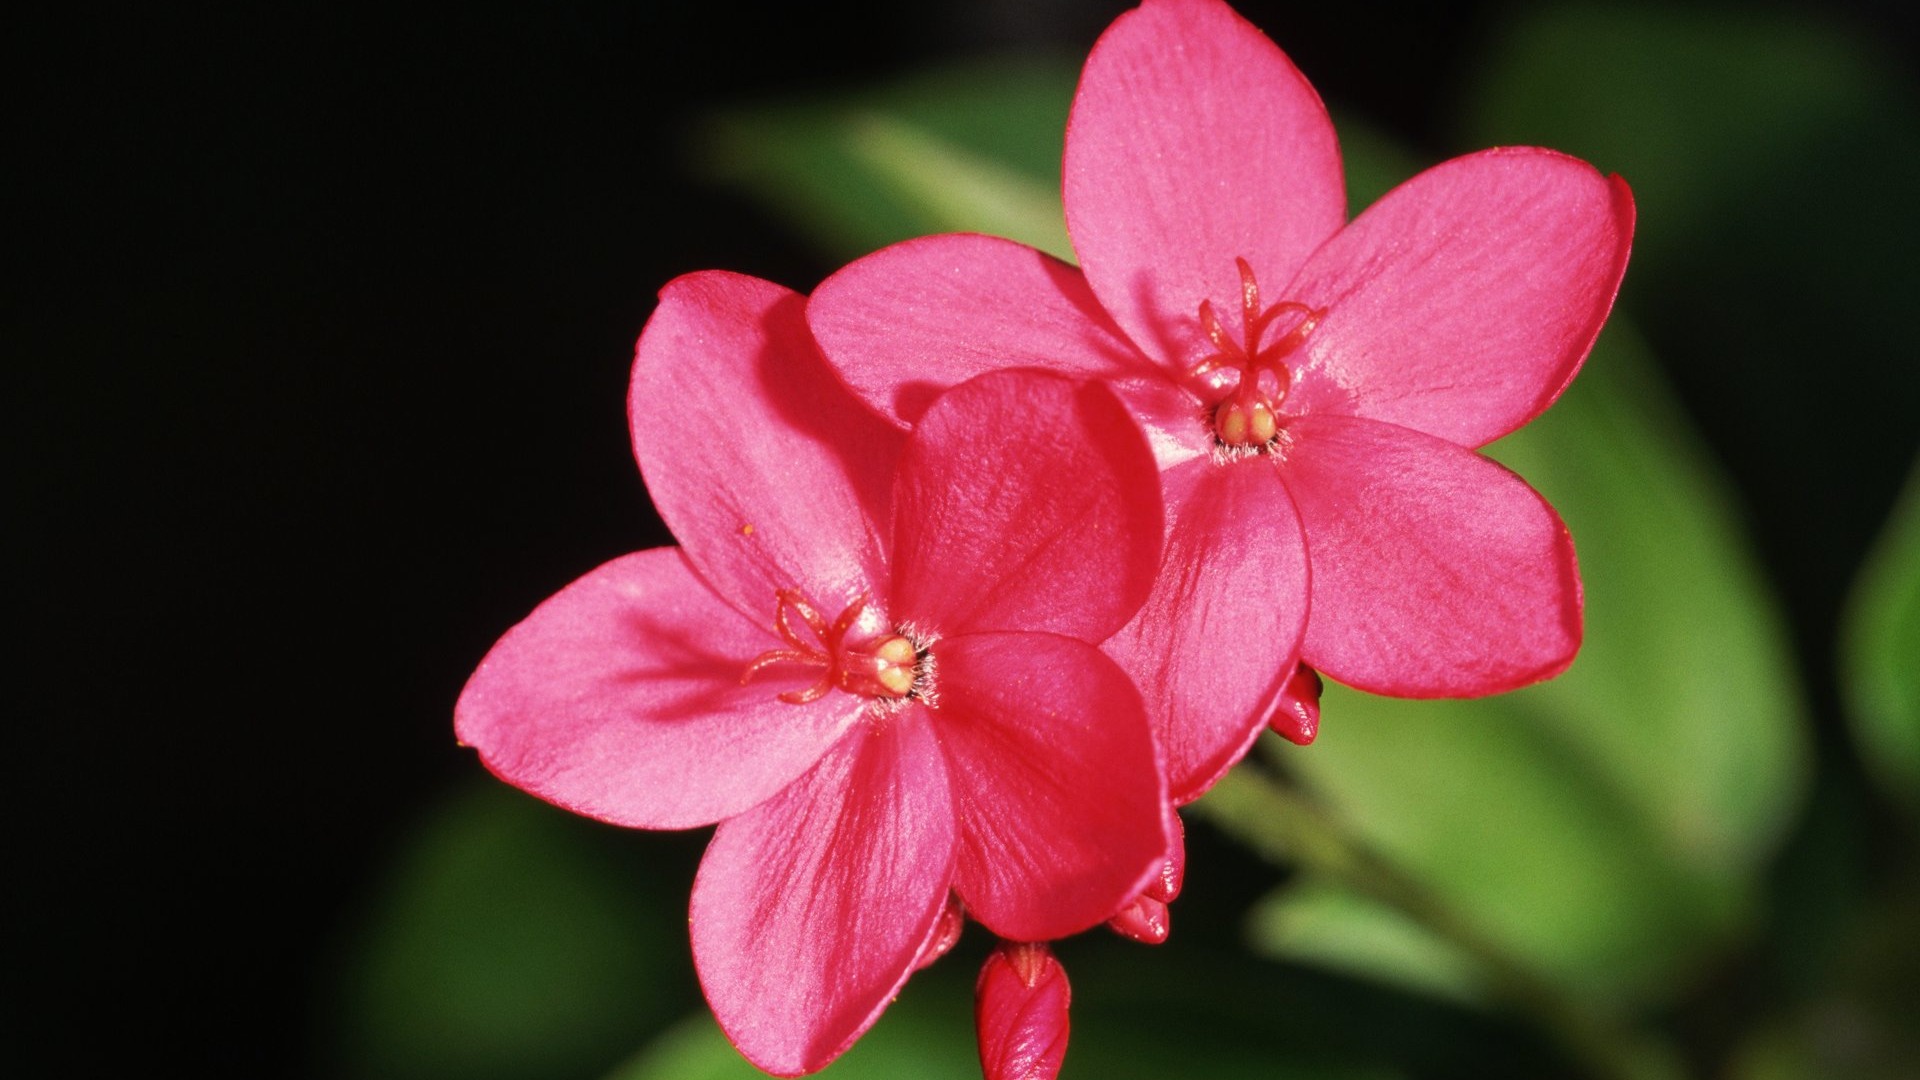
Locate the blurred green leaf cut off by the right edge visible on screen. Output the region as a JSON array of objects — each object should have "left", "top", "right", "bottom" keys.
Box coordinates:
[{"left": 1841, "top": 463, "right": 1920, "bottom": 813}]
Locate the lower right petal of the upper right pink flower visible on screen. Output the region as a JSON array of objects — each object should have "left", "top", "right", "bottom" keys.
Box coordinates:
[{"left": 1283, "top": 407, "right": 1580, "bottom": 698}]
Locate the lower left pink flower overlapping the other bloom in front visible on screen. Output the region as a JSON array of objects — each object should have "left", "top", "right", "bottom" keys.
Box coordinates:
[{"left": 455, "top": 273, "right": 1167, "bottom": 1076}]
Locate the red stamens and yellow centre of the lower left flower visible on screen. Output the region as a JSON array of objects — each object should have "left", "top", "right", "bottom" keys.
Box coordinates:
[{"left": 739, "top": 588, "right": 927, "bottom": 705}]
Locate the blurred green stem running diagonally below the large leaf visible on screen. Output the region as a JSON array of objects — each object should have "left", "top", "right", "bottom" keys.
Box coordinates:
[{"left": 1192, "top": 765, "right": 1686, "bottom": 1080}]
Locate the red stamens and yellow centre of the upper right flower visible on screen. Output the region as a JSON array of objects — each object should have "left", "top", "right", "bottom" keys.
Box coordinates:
[{"left": 1187, "top": 259, "right": 1327, "bottom": 450}]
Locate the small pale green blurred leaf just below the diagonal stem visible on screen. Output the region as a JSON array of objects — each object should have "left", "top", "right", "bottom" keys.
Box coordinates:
[{"left": 1252, "top": 882, "right": 1488, "bottom": 1005}]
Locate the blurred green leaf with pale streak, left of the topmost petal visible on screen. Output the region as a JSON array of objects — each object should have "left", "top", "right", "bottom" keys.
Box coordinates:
[{"left": 701, "top": 60, "right": 1079, "bottom": 258}]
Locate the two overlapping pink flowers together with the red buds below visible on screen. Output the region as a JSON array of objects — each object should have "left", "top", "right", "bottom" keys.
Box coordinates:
[{"left": 457, "top": 0, "right": 1632, "bottom": 1076}]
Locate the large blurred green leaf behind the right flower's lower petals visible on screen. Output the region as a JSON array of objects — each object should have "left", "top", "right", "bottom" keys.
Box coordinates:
[{"left": 1281, "top": 321, "right": 1803, "bottom": 1001}]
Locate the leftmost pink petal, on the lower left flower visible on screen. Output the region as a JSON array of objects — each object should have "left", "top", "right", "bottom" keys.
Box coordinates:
[{"left": 453, "top": 548, "right": 860, "bottom": 828}]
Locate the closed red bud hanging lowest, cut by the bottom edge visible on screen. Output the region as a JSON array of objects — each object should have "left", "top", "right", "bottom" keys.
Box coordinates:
[{"left": 973, "top": 942, "right": 1073, "bottom": 1080}]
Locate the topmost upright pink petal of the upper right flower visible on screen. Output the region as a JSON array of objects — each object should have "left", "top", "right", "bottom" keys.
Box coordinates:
[{"left": 1066, "top": 0, "right": 1346, "bottom": 363}]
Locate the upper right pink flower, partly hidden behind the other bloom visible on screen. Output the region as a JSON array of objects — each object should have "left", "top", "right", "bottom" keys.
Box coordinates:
[{"left": 808, "top": 0, "right": 1632, "bottom": 801}]
